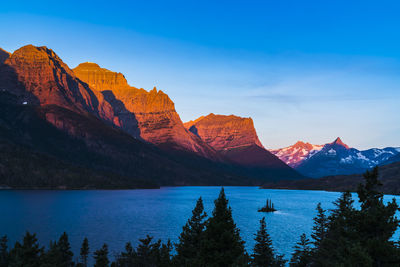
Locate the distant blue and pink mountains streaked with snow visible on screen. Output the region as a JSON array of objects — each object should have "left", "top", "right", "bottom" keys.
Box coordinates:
[{"left": 271, "top": 137, "right": 400, "bottom": 178}]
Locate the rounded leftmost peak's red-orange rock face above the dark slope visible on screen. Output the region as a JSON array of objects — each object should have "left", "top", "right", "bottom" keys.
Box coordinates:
[{"left": 0, "top": 45, "right": 117, "bottom": 124}]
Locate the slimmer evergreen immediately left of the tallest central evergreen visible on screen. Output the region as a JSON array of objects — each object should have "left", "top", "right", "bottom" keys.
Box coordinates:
[{"left": 174, "top": 197, "right": 207, "bottom": 266}]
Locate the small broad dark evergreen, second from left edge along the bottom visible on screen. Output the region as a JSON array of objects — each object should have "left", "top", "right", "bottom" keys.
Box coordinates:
[{"left": 9, "top": 232, "right": 43, "bottom": 267}]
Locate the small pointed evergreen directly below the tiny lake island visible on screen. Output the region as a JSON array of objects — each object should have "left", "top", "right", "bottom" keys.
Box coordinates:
[{"left": 251, "top": 217, "right": 286, "bottom": 267}]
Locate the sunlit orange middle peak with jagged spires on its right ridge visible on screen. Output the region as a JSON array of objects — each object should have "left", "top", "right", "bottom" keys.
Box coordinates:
[{"left": 74, "top": 63, "right": 219, "bottom": 159}]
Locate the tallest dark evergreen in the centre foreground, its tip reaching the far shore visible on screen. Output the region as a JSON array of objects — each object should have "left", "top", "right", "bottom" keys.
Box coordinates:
[{"left": 201, "top": 188, "right": 248, "bottom": 266}]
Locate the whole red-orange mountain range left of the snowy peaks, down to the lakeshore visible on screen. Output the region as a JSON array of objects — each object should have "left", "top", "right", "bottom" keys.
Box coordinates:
[{"left": 0, "top": 45, "right": 304, "bottom": 188}]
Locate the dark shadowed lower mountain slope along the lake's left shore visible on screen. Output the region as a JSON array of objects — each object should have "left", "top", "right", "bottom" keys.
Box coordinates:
[{"left": 0, "top": 92, "right": 250, "bottom": 188}]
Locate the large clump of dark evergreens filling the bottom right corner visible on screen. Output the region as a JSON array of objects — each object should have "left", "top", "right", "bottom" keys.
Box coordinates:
[{"left": 313, "top": 168, "right": 400, "bottom": 266}]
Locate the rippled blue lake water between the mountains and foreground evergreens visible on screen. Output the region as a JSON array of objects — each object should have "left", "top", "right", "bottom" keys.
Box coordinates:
[{"left": 0, "top": 187, "right": 397, "bottom": 258}]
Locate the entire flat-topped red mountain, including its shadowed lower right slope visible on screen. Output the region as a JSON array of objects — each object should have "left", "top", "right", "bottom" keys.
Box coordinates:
[{"left": 185, "top": 113, "right": 301, "bottom": 179}]
